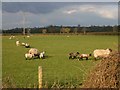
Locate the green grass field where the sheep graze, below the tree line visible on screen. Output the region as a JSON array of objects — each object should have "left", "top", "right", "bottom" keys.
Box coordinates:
[{"left": 2, "top": 35, "right": 118, "bottom": 88}]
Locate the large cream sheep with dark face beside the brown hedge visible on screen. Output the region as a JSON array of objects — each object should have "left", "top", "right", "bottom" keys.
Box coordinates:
[{"left": 93, "top": 49, "right": 112, "bottom": 60}]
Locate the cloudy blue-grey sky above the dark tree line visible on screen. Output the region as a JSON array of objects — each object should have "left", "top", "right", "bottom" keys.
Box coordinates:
[{"left": 2, "top": 0, "right": 118, "bottom": 29}]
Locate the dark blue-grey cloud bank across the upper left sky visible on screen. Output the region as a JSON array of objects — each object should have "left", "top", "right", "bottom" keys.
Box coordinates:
[{"left": 2, "top": 2, "right": 116, "bottom": 14}]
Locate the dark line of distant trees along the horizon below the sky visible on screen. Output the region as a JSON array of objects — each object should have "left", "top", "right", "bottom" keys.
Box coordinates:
[{"left": 2, "top": 25, "right": 118, "bottom": 34}]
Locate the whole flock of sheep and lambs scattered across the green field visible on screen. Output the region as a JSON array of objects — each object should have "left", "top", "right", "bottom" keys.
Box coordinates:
[{"left": 9, "top": 36, "right": 112, "bottom": 60}]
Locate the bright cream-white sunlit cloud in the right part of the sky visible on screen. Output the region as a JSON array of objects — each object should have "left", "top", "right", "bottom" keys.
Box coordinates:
[{"left": 64, "top": 4, "right": 118, "bottom": 19}]
